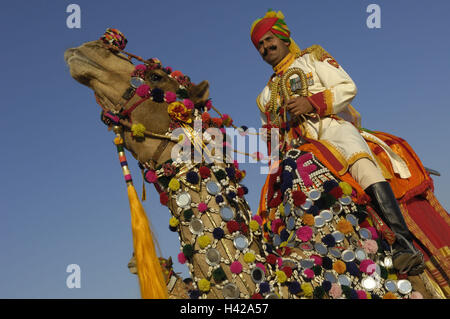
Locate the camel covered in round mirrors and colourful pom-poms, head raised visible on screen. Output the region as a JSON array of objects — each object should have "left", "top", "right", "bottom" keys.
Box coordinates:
[{"left": 64, "top": 30, "right": 448, "bottom": 299}]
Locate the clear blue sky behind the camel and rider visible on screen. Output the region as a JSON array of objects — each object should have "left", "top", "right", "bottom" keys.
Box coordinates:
[{"left": 0, "top": 0, "right": 450, "bottom": 298}]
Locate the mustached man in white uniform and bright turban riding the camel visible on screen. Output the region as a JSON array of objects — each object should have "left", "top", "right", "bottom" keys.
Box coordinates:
[{"left": 251, "top": 11, "right": 424, "bottom": 275}]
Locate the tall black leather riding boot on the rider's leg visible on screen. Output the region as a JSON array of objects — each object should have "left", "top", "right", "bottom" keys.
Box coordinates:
[{"left": 364, "top": 182, "right": 425, "bottom": 275}]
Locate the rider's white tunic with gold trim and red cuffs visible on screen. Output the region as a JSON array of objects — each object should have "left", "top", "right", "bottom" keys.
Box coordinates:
[{"left": 257, "top": 53, "right": 409, "bottom": 175}]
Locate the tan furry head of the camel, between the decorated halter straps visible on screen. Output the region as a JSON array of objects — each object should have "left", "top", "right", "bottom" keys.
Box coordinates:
[{"left": 64, "top": 33, "right": 209, "bottom": 162}]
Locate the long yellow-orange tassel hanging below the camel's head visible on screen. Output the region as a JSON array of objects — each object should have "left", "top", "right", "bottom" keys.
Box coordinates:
[{"left": 127, "top": 184, "right": 168, "bottom": 299}]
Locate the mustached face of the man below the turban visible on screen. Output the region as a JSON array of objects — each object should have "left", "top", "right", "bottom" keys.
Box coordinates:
[{"left": 258, "top": 31, "right": 289, "bottom": 66}]
